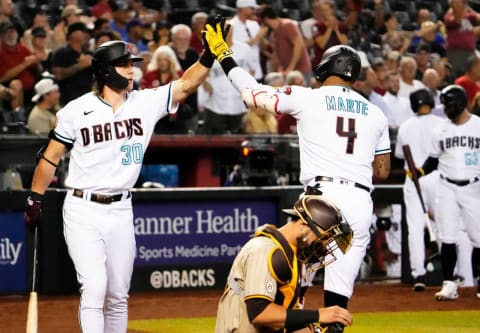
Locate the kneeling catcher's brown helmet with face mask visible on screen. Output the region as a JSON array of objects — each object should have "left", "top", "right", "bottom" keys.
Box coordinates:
[{"left": 283, "top": 195, "right": 353, "bottom": 266}]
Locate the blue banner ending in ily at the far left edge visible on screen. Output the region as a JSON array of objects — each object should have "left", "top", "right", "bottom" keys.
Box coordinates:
[{"left": 0, "top": 212, "right": 27, "bottom": 292}]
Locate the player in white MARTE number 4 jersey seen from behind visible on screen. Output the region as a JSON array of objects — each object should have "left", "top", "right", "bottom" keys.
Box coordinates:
[{"left": 204, "top": 24, "right": 391, "bottom": 332}]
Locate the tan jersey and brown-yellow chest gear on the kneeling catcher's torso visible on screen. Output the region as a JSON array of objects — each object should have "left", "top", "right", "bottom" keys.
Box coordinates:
[{"left": 215, "top": 225, "right": 299, "bottom": 333}]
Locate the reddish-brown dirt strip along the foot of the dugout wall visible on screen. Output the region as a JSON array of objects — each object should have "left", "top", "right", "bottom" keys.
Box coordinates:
[{"left": 0, "top": 283, "right": 480, "bottom": 333}]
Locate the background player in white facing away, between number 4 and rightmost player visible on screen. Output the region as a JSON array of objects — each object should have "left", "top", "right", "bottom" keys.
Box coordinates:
[{"left": 395, "top": 88, "right": 444, "bottom": 291}]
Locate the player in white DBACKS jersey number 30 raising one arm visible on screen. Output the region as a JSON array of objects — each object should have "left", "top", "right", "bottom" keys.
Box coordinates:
[{"left": 25, "top": 37, "right": 214, "bottom": 333}]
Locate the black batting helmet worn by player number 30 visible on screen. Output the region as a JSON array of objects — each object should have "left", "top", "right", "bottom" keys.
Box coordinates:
[{"left": 92, "top": 41, "right": 143, "bottom": 89}]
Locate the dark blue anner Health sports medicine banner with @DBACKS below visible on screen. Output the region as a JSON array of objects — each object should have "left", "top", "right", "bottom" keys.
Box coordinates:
[{"left": 132, "top": 199, "right": 278, "bottom": 290}]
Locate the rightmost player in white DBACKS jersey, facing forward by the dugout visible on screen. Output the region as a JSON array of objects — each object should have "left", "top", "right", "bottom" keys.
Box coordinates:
[{"left": 410, "top": 85, "right": 480, "bottom": 301}]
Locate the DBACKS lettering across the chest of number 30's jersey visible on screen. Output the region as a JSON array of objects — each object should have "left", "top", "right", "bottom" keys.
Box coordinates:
[{"left": 80, "top": 118, "right": 143, "bottom": 146}]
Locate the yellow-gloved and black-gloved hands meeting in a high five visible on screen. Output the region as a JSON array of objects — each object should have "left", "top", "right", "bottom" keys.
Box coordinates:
[{"left": 202, "top": 15, "right": 233, "bottom": 62}]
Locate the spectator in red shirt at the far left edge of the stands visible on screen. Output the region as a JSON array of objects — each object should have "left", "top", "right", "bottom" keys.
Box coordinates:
[{"left": 0, "top": 21, "right": 41, "bottom": 108}]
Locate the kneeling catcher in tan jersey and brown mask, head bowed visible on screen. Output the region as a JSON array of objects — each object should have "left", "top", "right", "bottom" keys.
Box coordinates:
[{"left": 215, "top": 195, "right": 353, "bottom": 333}]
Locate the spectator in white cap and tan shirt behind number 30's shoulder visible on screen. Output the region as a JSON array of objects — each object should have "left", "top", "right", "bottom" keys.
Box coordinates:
[{"left": 27, "top": 78, "right": 60, "bottom": 134}]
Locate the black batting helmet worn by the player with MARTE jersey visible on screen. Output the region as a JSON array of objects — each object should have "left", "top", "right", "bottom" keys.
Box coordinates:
[{"left": 315, "top": 45, "right": 361, "bottom": 82}]
